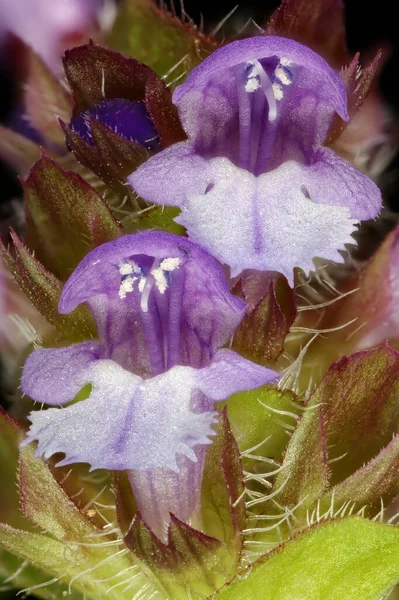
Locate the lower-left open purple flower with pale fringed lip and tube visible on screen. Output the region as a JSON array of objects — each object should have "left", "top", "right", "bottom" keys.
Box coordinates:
[{"left": 21, "top": 232, "right": 277, "bottom": 539}]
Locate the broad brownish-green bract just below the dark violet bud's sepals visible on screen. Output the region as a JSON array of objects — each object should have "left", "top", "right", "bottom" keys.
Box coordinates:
[{"left": 23, "top": 153, "right": 121, "bottom": 280}]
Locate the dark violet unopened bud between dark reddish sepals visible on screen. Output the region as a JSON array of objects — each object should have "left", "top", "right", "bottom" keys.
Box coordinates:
[{"left": 70, "top": 98, "right": 159, "bottom": 150}]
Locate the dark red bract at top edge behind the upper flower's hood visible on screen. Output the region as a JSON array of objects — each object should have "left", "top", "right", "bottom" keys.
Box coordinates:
[{"left": 265, "top": 0, "right": 348, "bottom": 66}]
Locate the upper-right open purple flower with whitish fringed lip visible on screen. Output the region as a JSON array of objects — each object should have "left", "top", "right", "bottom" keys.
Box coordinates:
[{"left": 128, "top": 36, "right": 381, "bottom": 282}]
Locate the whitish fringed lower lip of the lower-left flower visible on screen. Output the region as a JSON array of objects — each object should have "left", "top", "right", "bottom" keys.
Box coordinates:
[{"left": 24, "top": 360, "right": 217, "bottom": 472}]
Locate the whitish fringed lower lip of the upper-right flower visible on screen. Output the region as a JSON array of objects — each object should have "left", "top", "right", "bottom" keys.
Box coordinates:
[{"left": 169, "top": 158, "right": 363, "bottom": 285}]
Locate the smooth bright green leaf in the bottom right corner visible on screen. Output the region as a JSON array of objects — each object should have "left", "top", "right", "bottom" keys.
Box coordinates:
[{"left": 213, "top": 518, "right": 399, "bottom": 600}]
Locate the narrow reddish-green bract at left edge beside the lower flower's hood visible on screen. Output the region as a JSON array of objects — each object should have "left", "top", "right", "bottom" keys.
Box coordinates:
[{"left": 0, "top": 232, "right": 96, "bottom": 342}]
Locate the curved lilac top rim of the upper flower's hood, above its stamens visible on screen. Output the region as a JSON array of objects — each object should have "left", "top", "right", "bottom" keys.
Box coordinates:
[{"left": 173, "top": 36, "right": 349, "bottom": 121}]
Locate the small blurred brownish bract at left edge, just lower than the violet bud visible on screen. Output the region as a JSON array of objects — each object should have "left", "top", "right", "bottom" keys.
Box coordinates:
[{"left": 0, "top": 125, "right": 40, "bottom": 175}]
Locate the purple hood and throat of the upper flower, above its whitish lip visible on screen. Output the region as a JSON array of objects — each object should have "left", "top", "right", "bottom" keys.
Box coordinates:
[{"left": 173, "top": 36, "right": 348, "bottom": 175}]
